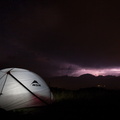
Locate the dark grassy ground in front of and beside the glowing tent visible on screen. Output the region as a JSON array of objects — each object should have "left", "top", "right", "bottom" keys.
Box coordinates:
[{"left": 1, "top": 88, "right": 120, "bottom": 120}]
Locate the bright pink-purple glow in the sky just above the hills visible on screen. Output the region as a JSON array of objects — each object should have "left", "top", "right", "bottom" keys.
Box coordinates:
[{"left": 58, "top": 64, "right": 120, "bottom": 77}]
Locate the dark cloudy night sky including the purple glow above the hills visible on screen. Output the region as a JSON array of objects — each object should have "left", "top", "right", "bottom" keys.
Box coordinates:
[{"left": 0, "top": 0, "right": 120, "bottom": 77}]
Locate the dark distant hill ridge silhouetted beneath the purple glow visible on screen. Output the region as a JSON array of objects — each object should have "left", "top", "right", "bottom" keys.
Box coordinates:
[{"left": 45, "top": 74, "right": 120, "bottom": 89}]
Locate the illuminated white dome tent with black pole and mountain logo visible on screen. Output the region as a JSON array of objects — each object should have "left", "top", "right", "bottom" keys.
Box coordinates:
[{"left": 0, "top": 68, "right": 53, "bottom": 110}]
